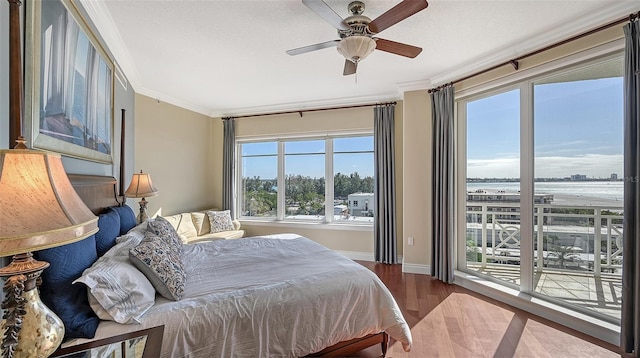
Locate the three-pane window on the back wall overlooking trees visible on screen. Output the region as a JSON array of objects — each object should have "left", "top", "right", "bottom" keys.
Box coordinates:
[{"left": 237, "top": 135, "right": 375, "bottom": 224}]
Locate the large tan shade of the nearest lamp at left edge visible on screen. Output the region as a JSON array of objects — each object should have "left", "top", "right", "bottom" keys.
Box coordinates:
[{"left": 0, "top": 149, "right": 98, "bottom": 256}]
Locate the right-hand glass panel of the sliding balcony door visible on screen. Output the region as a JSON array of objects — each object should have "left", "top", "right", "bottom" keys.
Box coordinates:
[{"left": 533, "top": 58, "right": 624, "bottom": 319}]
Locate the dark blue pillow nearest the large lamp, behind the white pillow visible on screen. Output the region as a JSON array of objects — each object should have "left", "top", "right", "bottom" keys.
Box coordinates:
[{"left": 33, "top": 235, "right": 100, "bottom": 340}]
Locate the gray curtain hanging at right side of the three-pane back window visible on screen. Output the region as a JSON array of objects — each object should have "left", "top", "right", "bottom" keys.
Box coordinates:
[{"left": 373, "top": 104, "right": 398, "bottom": 264}]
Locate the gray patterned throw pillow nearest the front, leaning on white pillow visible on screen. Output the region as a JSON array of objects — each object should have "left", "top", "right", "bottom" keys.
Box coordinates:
[{"left": 129, "top": 231, "right": 187, "bottom": 301}]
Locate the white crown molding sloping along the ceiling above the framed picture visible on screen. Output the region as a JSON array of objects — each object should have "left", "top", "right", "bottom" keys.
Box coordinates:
[{"left": 79, "top": 0, "right": 142, "bottom": 91}]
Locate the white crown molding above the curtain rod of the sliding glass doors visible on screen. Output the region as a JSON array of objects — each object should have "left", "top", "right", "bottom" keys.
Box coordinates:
[{"left": 431, "top": 2, "right": 639, "bottom": 83}]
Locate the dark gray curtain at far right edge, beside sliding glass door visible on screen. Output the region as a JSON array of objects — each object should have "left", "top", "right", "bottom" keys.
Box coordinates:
[{"left": 620, "top": 18, "right": 640, "bottom": 356}]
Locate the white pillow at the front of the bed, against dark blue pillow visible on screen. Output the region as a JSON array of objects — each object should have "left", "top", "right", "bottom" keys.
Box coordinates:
[{"left": 73, "top": 235, "right": 156, "bottom": 324}]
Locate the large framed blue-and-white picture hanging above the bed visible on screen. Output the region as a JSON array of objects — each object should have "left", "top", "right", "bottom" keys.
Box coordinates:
[{"left": 24, "top": 0, "right": 115, "bottom": 164}]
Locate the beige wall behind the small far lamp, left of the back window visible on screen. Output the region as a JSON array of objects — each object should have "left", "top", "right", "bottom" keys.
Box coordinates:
[{"left": 132, "top": 95, "right": 222, "bottom": 216}]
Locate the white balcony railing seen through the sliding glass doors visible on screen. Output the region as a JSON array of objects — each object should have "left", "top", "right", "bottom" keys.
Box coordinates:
[{"left": 467, "top": 202, "right": 623, "bottom": 276}]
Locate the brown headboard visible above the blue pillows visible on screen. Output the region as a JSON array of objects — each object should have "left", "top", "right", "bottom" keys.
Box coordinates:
[{"left": 68, "top": 174, "right": 124, "bottom": 215}]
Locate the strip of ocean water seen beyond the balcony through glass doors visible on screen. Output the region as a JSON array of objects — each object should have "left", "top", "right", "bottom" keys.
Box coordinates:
[{"left": 467, "top": 181, "right": 624, "bottom": 203}]
